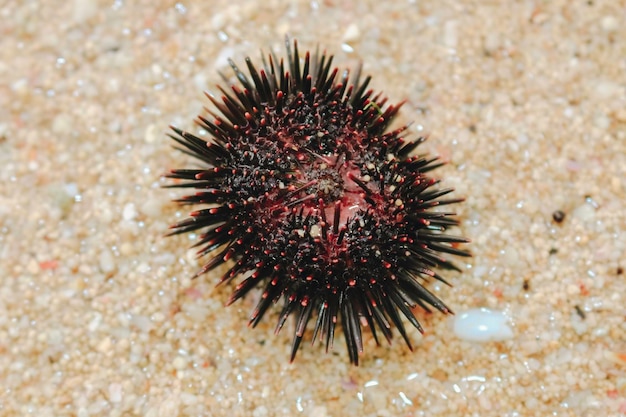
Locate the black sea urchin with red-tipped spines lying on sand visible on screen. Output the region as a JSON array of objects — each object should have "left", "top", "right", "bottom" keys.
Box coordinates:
[{"left": 166, "top": 41, "right": 469, "bottom": 365}]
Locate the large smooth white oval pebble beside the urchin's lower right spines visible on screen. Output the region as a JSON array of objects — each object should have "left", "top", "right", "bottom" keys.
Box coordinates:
[{"left": 454, "top": 308, "right": 513, "bottom": 342}]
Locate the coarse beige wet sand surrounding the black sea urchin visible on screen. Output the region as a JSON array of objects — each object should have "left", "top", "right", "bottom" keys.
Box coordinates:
[{"left": 0, "top": 0, "right": 626, "bottom": 417}]
